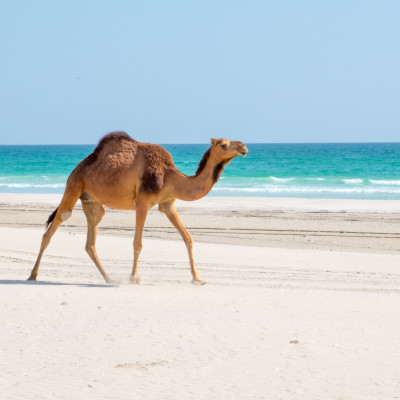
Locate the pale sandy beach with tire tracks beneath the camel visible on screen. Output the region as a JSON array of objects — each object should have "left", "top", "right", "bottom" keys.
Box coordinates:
[{"left": 0, "top": 194, "right": 400, "bottom": 400}]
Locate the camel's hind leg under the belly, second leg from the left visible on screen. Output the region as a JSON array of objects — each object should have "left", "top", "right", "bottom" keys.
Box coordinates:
[{"left": 82, "top": 200, "right": 116, "bottom": 283}]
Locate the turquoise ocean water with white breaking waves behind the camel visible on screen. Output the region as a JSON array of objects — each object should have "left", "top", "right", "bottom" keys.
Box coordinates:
[{"left": 0, "top": 143, "right": 400, "bottom": 199}]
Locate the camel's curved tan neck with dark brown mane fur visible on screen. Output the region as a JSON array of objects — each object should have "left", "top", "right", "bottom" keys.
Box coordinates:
[{"left": 169, "top": 148, "right": 224, "bottom": 201}]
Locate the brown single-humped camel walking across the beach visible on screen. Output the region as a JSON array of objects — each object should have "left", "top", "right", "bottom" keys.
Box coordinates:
[{"left": 28, "top": 131, "right": 247, "bottom": 285}]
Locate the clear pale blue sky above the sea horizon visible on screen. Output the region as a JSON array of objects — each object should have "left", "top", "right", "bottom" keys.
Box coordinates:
[{"left": 0, "top": 0, "right": 400, "bottom": 144}]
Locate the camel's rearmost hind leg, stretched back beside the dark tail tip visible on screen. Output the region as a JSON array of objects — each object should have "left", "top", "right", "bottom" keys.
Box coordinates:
[{"left": 28, "top": 187, "right": 80, "bottom": 281}]
